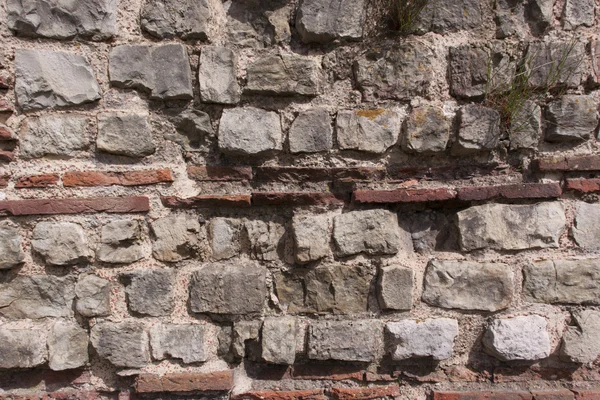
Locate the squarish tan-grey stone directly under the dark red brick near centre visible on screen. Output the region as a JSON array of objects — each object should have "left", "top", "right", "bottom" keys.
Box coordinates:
[{"left": 333, "top": 210, "right": 405, "bottom": 257}]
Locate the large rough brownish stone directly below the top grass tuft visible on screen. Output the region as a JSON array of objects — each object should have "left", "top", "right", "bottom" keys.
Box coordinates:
[{"left": 354, "top": 43, "right": 436, "bottom": 101}]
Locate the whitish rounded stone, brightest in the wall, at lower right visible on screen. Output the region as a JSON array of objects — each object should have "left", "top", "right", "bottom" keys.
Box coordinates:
[{"left": 483, "top": 315, "right": 551, "bottom": 361}]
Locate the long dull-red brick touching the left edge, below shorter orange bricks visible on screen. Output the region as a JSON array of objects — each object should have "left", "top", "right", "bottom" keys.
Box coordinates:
[{"left": 0, "top": 197, "right": 150, "bottom": 216}]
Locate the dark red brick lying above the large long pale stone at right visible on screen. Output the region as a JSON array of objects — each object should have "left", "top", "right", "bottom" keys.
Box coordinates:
[{"left": 457, "top": 182, "right": 562, "bottom": 201}]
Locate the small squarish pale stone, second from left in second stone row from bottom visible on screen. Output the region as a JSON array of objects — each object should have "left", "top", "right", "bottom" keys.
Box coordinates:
[{"left": 75, "top": 274, "right": 110, "bottom": 317}]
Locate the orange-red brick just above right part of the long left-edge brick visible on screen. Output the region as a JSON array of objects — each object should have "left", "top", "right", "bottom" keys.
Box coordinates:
[{"left": 63, "top": 168, "right": 173, "bottom": 187}]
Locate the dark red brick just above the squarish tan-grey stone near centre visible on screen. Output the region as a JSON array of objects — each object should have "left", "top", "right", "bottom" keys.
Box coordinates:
[{"left": 352, "top": 188, "right": 456, "bottom": 204}]
